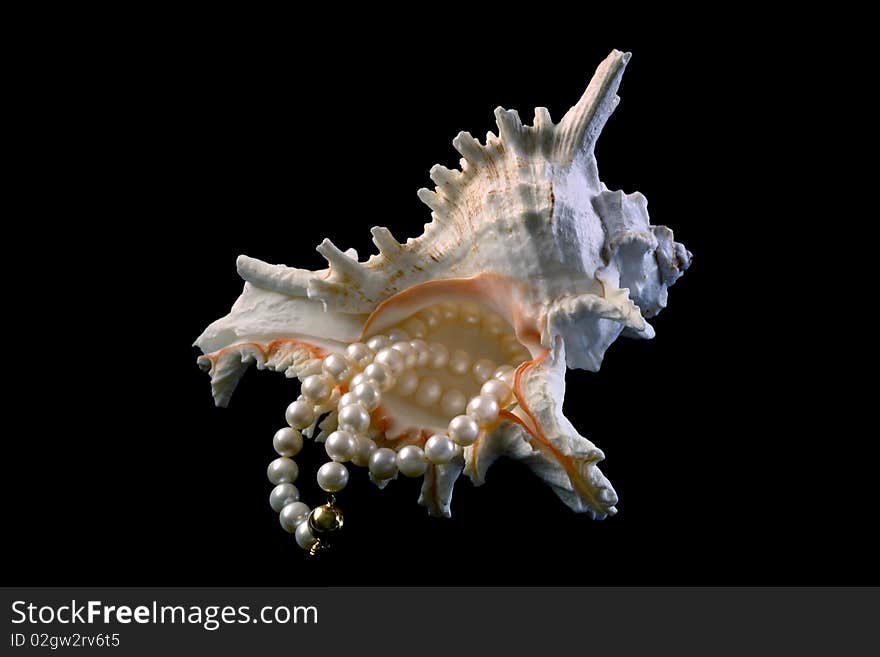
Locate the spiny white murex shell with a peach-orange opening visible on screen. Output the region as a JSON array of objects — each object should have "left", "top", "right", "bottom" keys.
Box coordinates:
[{"left": 195, "top": 50, "right": 691, "bottom": 518}]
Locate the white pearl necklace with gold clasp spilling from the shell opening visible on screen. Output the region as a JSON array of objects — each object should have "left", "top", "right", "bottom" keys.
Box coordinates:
[{"left": 267, "top": 320, "right": 519, "bottom": 554}]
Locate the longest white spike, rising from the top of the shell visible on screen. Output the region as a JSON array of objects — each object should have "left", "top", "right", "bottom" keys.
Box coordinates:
[{"left": 555, "top": 50, "right": 630, "bottom": 162}]
